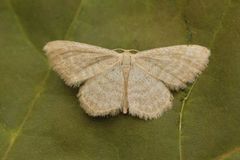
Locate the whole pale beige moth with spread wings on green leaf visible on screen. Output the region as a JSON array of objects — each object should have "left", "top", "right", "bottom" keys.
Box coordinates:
[{"left": 44, "top": 40, "right": 210, "bottom": 120}]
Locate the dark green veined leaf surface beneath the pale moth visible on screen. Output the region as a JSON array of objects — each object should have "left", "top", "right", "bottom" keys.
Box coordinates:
[{"left": 0, "top": 0, "right": 240, "bottom": 160}]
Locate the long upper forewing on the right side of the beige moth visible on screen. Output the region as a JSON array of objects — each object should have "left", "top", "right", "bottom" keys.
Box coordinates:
[{"left": 135, "top": 45, "right": 210, "bottom": 90}]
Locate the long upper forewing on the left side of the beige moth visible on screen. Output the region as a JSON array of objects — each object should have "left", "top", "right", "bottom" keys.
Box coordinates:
[{"left": 44, "top": 40, "right": 119, "bottom": 86}]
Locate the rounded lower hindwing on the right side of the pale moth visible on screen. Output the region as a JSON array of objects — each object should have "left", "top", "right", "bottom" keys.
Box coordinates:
[{"left": 128, "top": 64, "right": 173, "bottom": 119}]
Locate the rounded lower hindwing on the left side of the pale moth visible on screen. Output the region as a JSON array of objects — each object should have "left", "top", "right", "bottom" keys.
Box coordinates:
[{"left": 78, "top": 65, "right": 124, "bottom": 116}]
